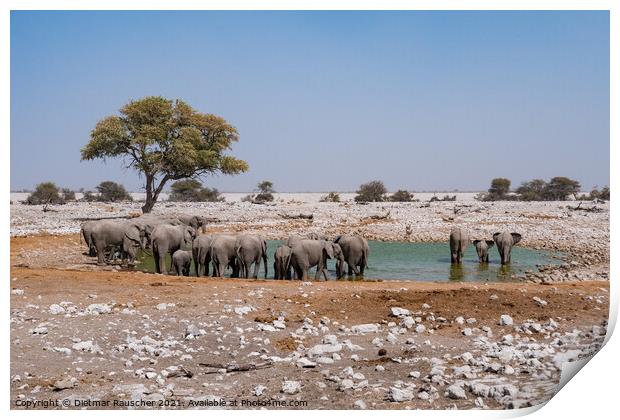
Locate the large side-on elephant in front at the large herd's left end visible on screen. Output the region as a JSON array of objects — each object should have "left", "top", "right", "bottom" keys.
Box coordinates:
[{"left": 90, "top": 220, "right": 150, "bottom": 265}]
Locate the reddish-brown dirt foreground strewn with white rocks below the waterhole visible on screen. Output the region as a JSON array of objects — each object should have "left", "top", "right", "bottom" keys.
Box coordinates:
[{"left": 10, "top": 234, "right": 609, "bottom": 409}]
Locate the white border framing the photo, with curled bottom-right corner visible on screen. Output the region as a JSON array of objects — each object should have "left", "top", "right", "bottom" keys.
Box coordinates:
[{"left": 0, "top": 0, "right": 620, "bottom": 419}]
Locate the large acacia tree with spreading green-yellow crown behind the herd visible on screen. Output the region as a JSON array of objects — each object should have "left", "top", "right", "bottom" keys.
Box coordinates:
[{"left": 82, "top": 96, "right": 248, "bottom": 213}]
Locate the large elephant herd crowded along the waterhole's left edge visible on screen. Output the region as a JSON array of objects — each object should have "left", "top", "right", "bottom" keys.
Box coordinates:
[{"left": 81, "top": 215, "right": 369, "bottom": 280}]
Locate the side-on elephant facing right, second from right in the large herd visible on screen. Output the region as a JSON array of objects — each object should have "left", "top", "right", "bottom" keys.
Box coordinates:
[{"left": 291, "top": 239, "right": 344, "bottom": 280}]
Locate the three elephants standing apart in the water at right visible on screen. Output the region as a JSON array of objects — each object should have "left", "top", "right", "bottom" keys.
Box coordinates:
[{"left": 450, "top": 227, "right": 521, "bottom": 265}]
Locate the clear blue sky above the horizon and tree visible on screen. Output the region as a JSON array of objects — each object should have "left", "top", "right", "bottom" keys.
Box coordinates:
[{"left": 11, "top": 11, "right": 610, "bottom": 192}]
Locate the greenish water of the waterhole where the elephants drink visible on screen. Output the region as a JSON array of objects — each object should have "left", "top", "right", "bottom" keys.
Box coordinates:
[{"left": 136, "top": 241, "right": 561, "bottom": 282}]
